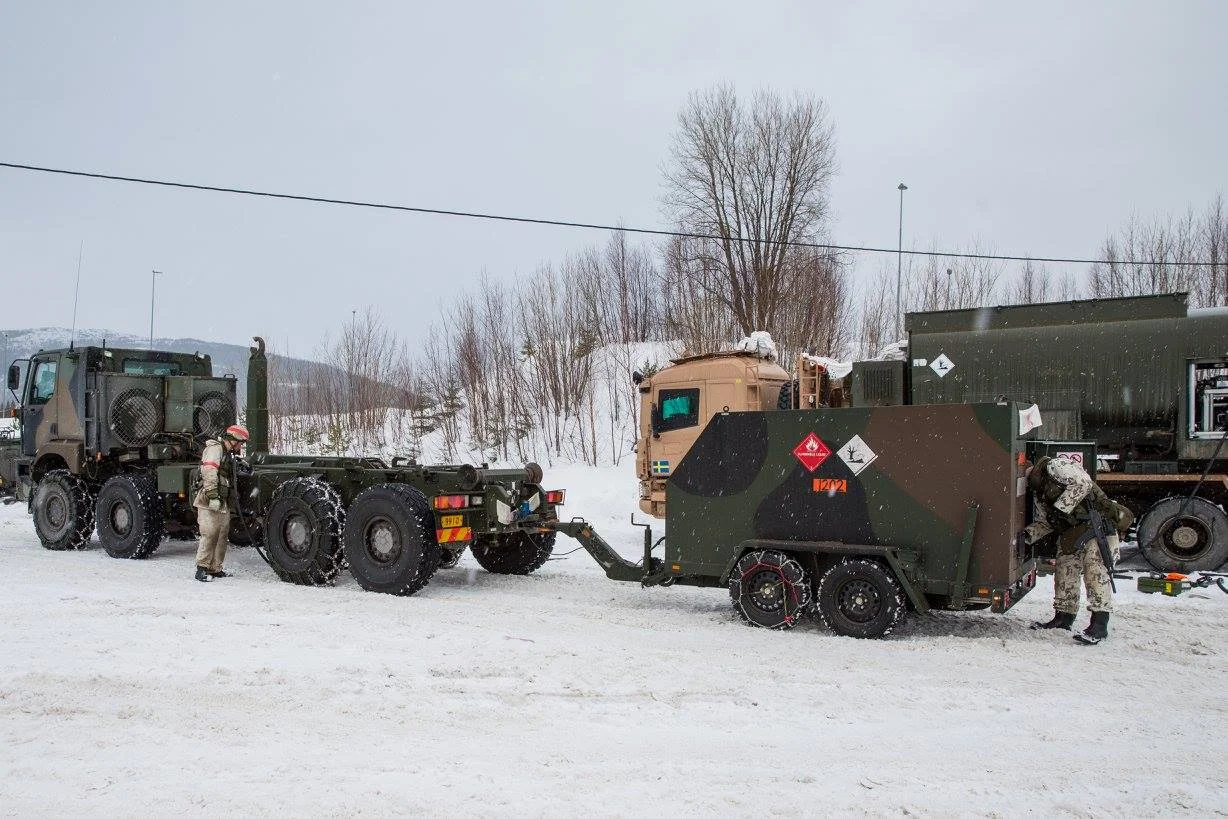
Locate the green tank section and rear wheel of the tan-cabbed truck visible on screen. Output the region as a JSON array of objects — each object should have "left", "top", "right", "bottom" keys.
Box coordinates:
[{"left": 850, "top": 293, "right": 1228, "bottom": 572}]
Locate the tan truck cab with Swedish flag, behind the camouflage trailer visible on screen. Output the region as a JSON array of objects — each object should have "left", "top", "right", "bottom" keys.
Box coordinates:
[{"left": 635, "top": 350, "right": 791, "bottom": 518}]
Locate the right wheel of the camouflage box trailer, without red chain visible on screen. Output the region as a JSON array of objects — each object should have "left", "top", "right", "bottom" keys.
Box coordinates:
[{"left": 819, "top": 559, "right": 905, "bottom": 637}]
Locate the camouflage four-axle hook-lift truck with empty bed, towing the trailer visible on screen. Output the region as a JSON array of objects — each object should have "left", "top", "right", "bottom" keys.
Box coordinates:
[{"left": 0, "top": 338, "right": 564, "bottom": 594}]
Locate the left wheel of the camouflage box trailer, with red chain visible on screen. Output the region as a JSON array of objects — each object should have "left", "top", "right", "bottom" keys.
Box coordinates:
[{"left": 729, "top": 550, "right": 810, "bottom": 629}]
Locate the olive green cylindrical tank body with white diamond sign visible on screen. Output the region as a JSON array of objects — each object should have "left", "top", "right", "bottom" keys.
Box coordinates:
[{"left": 907, "top": 296, "right": 1228, "bottom": 461}]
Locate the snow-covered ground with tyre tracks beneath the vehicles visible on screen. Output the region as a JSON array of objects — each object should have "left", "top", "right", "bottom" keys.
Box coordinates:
[{"left": 0, "top": 464, "right": 1228, "bottom": 817}]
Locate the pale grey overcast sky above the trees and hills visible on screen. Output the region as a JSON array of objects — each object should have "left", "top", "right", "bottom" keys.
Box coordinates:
[{"left": 0, "top": 0, "right": 1228, "bottom": 355}]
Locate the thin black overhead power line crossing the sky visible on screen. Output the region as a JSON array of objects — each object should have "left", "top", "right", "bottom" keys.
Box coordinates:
[{"left": 0, "top": 162, "right": 1212, "bottom": 268}]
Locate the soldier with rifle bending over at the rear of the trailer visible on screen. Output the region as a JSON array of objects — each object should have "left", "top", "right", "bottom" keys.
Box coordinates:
[{"left": 1024, "top": 457, "right": 1135, "bottom": 645}]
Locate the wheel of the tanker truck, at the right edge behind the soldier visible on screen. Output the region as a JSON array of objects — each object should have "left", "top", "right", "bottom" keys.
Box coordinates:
[{"left": 1138, "top": 497, "right": 1228, "bottom": 572}]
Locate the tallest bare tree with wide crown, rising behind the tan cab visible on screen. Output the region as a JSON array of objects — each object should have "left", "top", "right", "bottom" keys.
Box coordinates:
[{"left": 664, "top": 86, "right": 835, "bottom": 343}]
